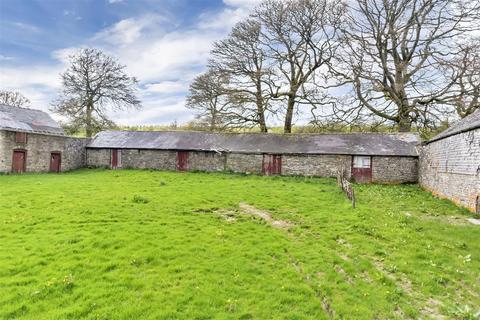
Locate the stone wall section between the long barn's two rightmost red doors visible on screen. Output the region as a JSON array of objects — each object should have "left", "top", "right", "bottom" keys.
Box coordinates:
[{"left": 282, "top": 155, "right": 352, "bottom": 177}]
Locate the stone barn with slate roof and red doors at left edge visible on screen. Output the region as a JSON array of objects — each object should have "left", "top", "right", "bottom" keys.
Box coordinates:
[{"left": 0, "top": 104, "right": 87, "bottom": 173}]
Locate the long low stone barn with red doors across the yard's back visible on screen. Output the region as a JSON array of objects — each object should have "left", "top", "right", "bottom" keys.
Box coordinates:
[{"left": 87, "top": 131, "right": 419, "bottom": 183}]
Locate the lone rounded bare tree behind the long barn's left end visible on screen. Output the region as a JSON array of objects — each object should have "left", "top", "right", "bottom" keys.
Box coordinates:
[{"left": 53, "top": 48, "right": 141, "bottom": 137}]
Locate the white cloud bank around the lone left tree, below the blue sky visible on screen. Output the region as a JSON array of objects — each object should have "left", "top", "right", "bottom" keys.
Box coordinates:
[{"left": 0, "top": 5, "right": 255, "bottom": 125}]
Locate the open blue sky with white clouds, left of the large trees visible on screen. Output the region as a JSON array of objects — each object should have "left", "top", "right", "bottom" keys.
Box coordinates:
[{"left": 0, "top": 0, "right": 259, "bottom": 125}]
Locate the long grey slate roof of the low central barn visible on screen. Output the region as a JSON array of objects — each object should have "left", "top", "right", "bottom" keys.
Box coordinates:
[{"left": 88, "top": 131, "right": 420, "bottom": 156}]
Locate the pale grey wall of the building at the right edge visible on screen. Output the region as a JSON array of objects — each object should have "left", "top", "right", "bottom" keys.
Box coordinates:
[{"left": 419, "top": 129, "right": 480, "bottom": 211}]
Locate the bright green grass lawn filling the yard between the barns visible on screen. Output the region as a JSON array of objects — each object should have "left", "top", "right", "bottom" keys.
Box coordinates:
[{"left": 0, "top": 170, "right": 480, "bottom": 319}]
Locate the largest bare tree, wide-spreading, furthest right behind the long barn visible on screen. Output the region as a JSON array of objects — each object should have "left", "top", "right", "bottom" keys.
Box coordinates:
[{"left": 336, "top": 0, "right": 480, "bottom": 131}]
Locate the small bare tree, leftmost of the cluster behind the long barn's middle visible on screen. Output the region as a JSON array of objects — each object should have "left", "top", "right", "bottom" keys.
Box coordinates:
[{"left": 186, "top": 69, "right": 231, "bottom": 131}]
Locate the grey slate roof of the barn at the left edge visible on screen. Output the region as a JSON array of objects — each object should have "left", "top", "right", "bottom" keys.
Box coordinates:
[{"left": 0, "top": 104, "right": 65, "bottom": 135}]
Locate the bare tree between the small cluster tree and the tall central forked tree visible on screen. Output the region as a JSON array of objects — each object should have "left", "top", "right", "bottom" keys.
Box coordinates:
[{"left": 210, "top": 19, "right": 271, "bottom": 132}]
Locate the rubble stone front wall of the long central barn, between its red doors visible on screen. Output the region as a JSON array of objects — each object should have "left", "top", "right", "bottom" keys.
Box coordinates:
[{"left": 87, "top": 149, "right": 418, "bottom": 183}]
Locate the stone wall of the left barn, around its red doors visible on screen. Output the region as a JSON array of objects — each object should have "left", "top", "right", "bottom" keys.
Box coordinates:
[{"left": 0, "top": 131, "right": 88, "bottom": 172}]
